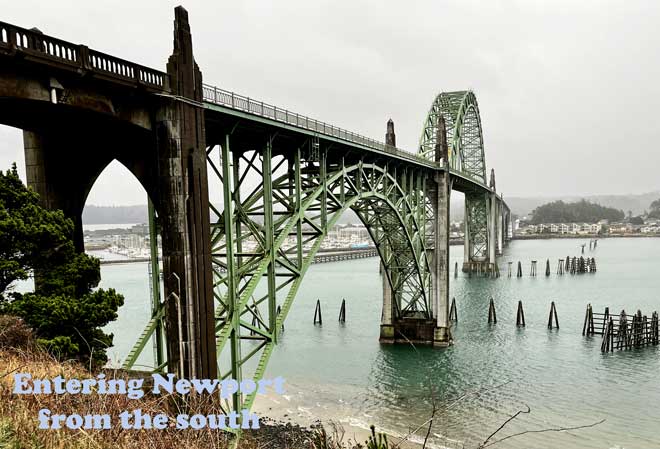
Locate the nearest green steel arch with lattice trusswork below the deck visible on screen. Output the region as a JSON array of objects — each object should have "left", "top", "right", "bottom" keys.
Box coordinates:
[{"left": 208, "top": 136, "right": 433, "bottom": 410}]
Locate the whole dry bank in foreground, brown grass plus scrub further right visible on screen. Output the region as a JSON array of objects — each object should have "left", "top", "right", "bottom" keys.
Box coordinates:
[{"left": 0, "top": 315, "right": 378, "bottom": 449}]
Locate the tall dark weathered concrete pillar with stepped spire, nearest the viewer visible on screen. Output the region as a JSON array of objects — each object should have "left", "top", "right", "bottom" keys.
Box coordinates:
[{"left": 156, "top": 7, "right": 217, "bottom": 378}]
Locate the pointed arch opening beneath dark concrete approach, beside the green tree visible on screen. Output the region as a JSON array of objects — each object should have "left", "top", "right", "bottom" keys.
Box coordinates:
[{"left": 82, "top": 159, "right": 164, "bottom": 370}]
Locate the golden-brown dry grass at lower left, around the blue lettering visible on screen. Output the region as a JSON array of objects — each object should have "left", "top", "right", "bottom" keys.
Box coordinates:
[{"left": 0, "top": 317, "right": 258, "bottom": 449}]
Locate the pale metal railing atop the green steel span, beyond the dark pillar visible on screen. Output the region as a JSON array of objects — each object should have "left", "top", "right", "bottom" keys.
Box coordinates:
[{"left": 203, "top": 84, "right": 436, "bottom": 164}]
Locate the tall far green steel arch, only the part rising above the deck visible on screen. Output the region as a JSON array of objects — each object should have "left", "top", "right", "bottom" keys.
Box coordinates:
[{"left": 417, "top": 90, "right": 486, "bottom": 184}]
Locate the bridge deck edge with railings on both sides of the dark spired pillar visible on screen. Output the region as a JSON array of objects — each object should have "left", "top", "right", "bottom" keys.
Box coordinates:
[{"left": 0, "top": 17, "right": 506, "bottom": 207}]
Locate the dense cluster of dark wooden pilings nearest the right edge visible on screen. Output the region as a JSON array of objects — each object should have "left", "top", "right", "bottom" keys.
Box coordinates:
[{"left": 582, "top": 304, "right": 660, "bottom": 352}]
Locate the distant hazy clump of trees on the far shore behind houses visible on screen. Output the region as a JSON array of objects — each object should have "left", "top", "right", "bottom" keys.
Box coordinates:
[{"left": 530, "top": 200, "right": 625, "bottom": 224}]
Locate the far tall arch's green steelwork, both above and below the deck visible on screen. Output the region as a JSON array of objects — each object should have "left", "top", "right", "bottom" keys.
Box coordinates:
[{"left": 418, "top": 90, "right": 494, "bottom": 262}]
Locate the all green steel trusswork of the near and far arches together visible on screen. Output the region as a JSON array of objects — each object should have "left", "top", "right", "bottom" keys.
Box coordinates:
[{"left": 121, "top": 87, "right": 508, "bottom": 410}]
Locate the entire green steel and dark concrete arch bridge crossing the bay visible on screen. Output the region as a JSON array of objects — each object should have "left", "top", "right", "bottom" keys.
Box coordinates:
[{"left": 0, "top": 7, "right": 510, "bottom": 409}]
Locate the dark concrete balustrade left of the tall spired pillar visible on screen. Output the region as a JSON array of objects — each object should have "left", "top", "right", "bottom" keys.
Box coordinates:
[{"left": 0, "top": 22, "right": 167, "bottom": 91}]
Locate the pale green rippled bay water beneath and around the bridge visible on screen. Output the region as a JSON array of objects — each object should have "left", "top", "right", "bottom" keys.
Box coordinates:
[{"left": 102, "top": 238, "right": 660, "bottom": 449}]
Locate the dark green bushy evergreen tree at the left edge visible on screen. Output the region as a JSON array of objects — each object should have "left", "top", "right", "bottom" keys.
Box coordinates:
[{"left": 0, "top": 165, "right": 124, "bottom": 363}]
